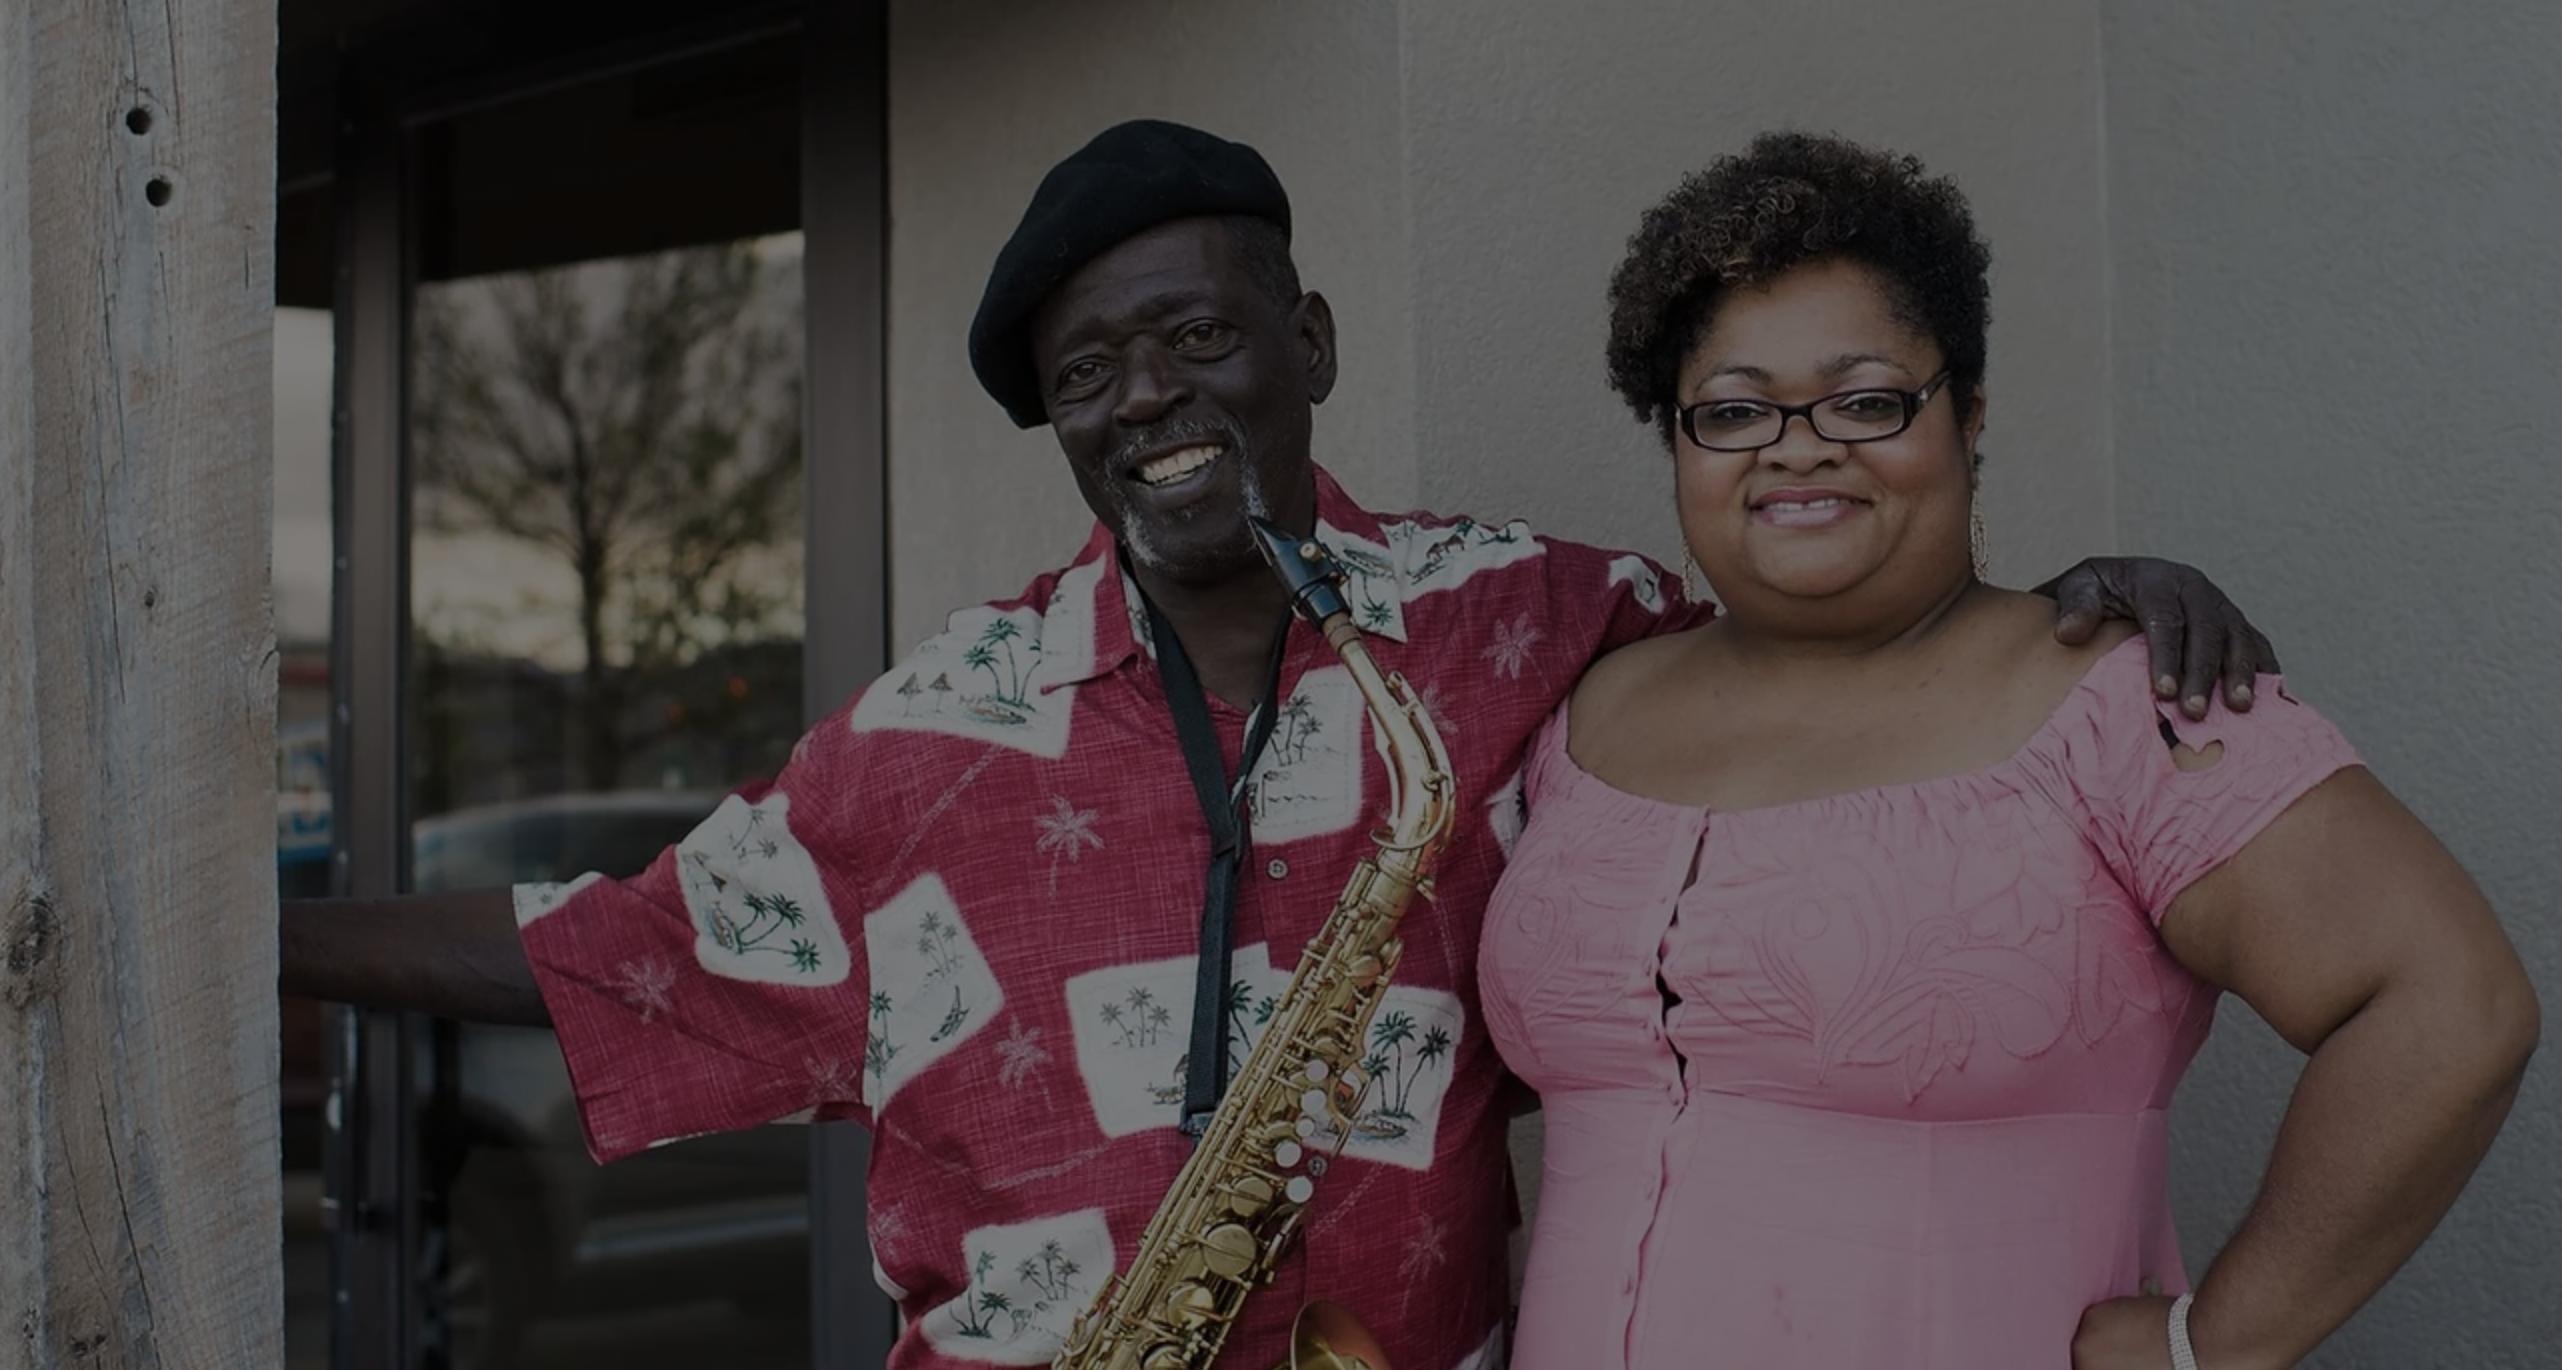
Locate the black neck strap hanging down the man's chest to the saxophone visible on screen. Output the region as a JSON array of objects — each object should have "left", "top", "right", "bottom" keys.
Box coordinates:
[{"left": 1140, "top": 583, "right": 1289, "bottom": 1140}]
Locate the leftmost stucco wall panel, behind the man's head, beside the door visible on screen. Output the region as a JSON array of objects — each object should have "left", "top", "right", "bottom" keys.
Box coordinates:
[{"left": 889, "top": 0, "right": 1414, "bottom": 648}]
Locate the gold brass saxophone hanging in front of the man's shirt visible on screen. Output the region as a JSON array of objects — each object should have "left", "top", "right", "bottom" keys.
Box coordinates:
[{"left": 1050, "top": 517, "right": 1458, "bottom": 1370}]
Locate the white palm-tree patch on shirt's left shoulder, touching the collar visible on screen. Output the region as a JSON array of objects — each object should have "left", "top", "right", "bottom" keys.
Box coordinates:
[{"left": 848, "top": 558, "right": 1104, "bottom": 761}]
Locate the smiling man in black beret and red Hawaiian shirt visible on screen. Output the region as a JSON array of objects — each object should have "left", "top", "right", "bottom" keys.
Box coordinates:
[{"left": 284, "top": 123, "right": 2262, "bottom": 1370}]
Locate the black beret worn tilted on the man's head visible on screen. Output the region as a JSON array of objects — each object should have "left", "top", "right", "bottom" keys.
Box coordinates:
[{"left": 968, "top": 118, "right": 1289, "bottom": 428}]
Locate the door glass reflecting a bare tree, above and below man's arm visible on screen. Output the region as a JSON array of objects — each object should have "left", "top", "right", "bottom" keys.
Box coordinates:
[{"left": 410, "top": 236, "right": 810, "bottom": 1370}]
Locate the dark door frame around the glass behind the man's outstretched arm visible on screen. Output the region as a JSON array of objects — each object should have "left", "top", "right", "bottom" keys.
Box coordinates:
[{"left": 325, "top": 0, "right": 897, "bottom": 1370}]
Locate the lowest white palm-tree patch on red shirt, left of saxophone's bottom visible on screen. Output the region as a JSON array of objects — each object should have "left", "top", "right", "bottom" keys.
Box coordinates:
[{"left": 920, "top": 1209, "right": 1114, "bottom": 1365}]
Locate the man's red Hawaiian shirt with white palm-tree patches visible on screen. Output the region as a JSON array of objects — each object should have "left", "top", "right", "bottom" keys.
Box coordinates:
[{"left": 518, "top": 474, "right": 1693, "bottom": 1370}]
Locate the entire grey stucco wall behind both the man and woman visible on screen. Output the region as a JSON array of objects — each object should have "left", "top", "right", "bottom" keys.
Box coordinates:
[{"left": 889, "top": 0, "right": 2562, "bottom": 1367}]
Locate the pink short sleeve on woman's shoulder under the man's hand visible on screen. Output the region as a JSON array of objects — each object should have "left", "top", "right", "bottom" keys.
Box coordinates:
[{"left": 2057, "top": 638, "right": 2357, "bottom": 922}]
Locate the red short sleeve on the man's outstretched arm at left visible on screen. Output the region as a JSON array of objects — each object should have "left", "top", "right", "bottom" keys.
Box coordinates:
[{"left": 515, "top": 714, "right": 869, "bottom": 1160}]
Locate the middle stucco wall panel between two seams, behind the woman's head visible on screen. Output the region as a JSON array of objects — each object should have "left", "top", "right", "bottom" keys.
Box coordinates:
[{"left": 1404, "top": 0, "right": 2111, "bottom": 581}]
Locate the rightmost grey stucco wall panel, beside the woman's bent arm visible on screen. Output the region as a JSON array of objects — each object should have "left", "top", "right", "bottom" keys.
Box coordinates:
[{"left": 2103, "top": 0, "right": 2562, "bottom": 1367}]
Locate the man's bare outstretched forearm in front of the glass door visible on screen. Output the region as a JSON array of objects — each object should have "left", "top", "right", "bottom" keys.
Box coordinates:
[{"left": 277, "top": 889, "right": 551, "bottom": 1024}]
